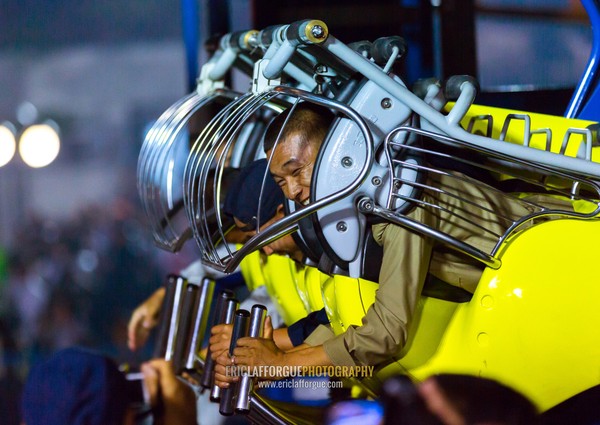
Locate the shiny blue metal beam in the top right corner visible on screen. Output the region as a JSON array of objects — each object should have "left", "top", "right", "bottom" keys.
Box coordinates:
[{"left": 565, "top": 0, "right": 600, "bottom": 121}]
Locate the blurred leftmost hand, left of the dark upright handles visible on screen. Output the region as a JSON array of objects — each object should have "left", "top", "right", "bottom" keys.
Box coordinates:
[{"left": 127, "top": 287, "right": 165, "bottom": 351}]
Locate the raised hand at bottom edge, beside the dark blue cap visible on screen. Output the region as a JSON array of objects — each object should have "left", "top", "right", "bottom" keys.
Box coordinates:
[{"left": 141, "top": 359, "right": 196, "bottom": 425}]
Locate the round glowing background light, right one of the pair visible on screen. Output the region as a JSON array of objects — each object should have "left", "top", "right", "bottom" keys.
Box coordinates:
[{"left": 19, "top": 124, "right": 60, "bottom": 168}]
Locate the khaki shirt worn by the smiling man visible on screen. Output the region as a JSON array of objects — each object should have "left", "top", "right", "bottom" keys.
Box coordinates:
[{"left": 318, "top": 174, "right": 533, "bottom": 366}]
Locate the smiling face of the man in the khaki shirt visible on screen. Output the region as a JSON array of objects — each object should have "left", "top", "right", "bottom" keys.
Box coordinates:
[{"left": 267, "top": 134, "right": 319, "bottom": 205}]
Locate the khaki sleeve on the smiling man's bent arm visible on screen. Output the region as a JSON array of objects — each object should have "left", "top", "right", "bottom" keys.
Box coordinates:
[{"left": 323, "top": 217, "right": 432, "bottom": 366}]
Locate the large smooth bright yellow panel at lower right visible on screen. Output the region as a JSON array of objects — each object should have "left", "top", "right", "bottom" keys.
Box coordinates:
[{"left": 410, "top": 220, "right": 600, "bottom": 410}]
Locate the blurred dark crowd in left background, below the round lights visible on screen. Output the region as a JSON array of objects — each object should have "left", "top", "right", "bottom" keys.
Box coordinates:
[{"left": 0, "top": 197, "right": 202, "bottom": 425}]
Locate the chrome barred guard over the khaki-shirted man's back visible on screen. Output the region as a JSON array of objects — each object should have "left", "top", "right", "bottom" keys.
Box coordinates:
[{"left": 366, "top": 126, "right": 600, "bottom": 268}]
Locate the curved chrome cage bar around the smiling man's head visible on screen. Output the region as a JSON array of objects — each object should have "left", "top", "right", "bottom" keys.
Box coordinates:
[{"left": 185, "top": 86, "right": 373, "bottom": 273}]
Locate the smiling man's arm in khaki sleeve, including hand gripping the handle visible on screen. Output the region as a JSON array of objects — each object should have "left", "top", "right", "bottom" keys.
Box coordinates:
[{"left": 219, "top": 219, "right": 433, "bottom": 383}]
